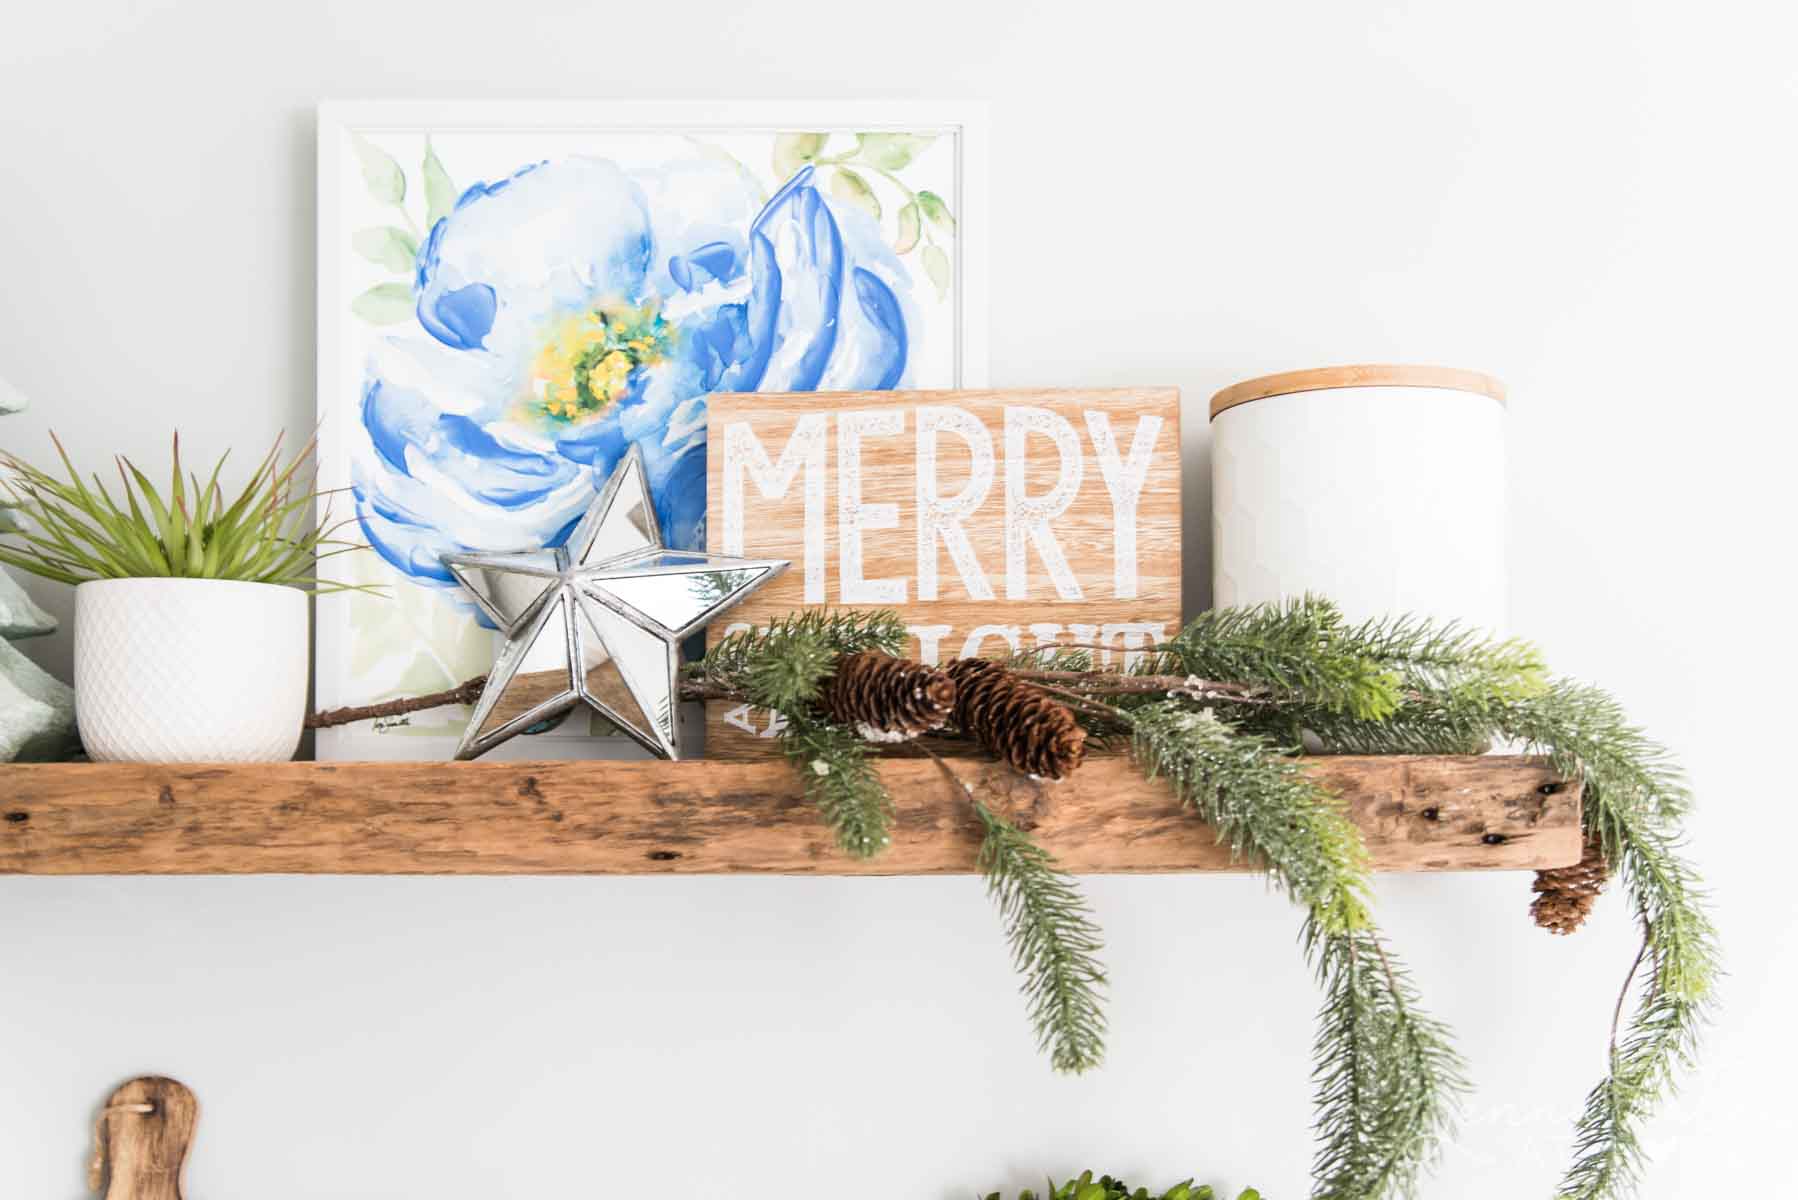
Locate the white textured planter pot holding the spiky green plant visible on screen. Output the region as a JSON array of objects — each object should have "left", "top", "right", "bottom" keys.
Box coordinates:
[{"left": 76, "top": 579, "right": 311, "bottom": 763}]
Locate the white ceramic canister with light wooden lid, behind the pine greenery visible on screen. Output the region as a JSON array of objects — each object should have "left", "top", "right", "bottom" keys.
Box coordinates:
[{"left": 1212, "top": 367, "right": 1505, "bottom": 633}]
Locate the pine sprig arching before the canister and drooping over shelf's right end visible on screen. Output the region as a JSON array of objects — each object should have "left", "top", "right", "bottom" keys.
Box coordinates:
[{"left": 1138, "top": 597, "right": 1721, "bottom": 1200}]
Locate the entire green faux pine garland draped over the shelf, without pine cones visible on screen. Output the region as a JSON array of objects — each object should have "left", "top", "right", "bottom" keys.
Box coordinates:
[{"left": 687, "top": 597, "right": 1717, "bottom": 1200}]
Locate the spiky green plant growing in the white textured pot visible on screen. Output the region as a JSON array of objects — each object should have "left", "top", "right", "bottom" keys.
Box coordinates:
[{"left": 0, "top": 434, "right": 361, "bottom": 592}]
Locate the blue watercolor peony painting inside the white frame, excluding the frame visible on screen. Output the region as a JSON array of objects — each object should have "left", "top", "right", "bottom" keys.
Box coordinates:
[{"left": 322, "top": 116, "right": 960, "bottom": 744}]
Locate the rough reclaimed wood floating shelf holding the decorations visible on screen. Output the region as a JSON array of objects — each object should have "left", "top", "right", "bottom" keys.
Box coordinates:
[{"left": 0, "top": 756, "right": 1580, "bottom": 874}]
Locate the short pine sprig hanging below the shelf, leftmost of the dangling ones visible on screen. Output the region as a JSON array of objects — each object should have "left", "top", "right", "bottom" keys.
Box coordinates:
[{"left": 975, "top": 801, "right": 1106, "bottom": 1074}]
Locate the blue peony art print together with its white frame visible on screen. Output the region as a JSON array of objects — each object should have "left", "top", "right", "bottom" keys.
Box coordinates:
[{"left": 316, "top": 101, "right": 985, "bottom": 759}]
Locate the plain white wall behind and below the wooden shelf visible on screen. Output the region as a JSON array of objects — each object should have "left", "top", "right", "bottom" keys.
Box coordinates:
[{"left": 0, "top": 0, "right": 1798, "bottom": 1200}]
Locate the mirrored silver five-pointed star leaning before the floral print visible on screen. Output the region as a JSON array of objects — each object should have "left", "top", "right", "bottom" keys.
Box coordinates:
[{"left": 444, "top": 446, "right": 788, "bottom": 759}]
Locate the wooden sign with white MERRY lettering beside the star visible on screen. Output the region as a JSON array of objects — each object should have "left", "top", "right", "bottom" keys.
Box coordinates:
[{"left": 707, "top": 387, "right": 1179, "bottom": 757}]
